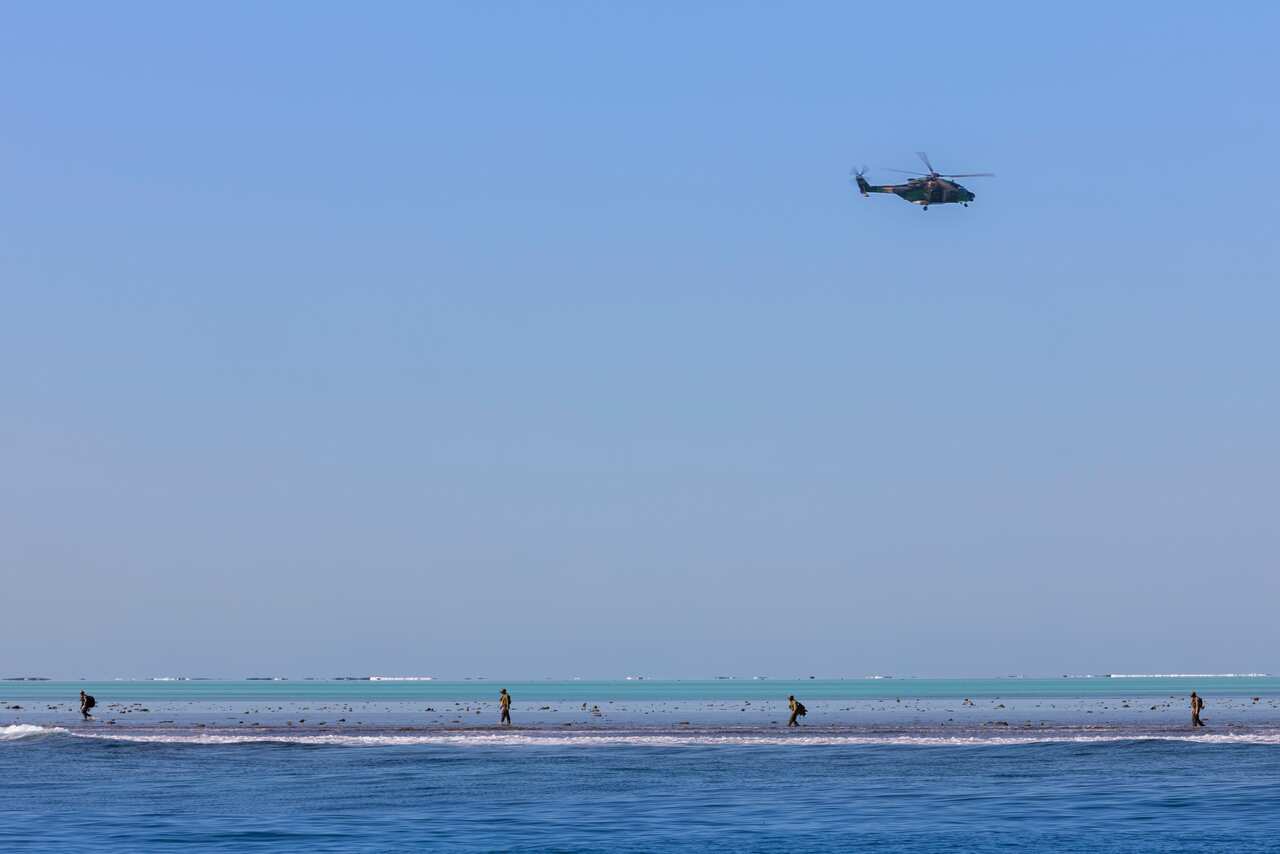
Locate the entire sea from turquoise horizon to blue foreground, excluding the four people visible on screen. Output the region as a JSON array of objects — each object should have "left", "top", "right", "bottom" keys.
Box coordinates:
[{"left": 0, "top": 676, "right": 1280, "bottom": 853}]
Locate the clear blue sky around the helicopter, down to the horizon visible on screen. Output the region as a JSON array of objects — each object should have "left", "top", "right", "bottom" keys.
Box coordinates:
[{"left": 0, "top": 3, "right": 1280, "bottom": 677}]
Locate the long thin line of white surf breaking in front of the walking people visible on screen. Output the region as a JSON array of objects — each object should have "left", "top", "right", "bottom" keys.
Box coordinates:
[{"left": 60, "top": 727, "right": 1280, "bottom": 748}]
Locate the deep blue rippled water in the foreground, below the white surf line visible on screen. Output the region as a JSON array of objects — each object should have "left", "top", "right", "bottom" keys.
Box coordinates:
[{"left": 0, "top": 732, "right": 1280, "bottom": 853}]
